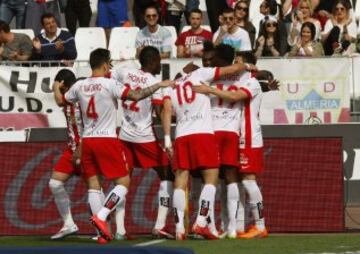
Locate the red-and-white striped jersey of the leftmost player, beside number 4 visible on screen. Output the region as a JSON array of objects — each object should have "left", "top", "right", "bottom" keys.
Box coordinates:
[{"left": 63, "top": 103, "right": 84, "bottom": 151}]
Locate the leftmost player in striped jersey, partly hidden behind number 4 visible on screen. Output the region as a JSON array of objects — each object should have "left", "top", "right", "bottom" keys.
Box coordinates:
[{"left": 49, "top": 69, "right": 83, "bottom": 240}]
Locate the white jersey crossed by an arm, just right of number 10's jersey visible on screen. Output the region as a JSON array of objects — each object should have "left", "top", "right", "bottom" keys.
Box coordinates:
[{"left": 211, "top": 72, "right": 250, "bottom": 135}]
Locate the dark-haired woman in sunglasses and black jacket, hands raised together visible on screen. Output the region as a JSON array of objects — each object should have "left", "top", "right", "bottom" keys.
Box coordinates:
[{"left": 255, "top": 16, "right": 288, "bottom": 57}]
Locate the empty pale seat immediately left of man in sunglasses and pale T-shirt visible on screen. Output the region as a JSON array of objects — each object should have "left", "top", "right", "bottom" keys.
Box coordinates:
[{"left": 108, "top": 27, "right": 139, "bottom": 60}]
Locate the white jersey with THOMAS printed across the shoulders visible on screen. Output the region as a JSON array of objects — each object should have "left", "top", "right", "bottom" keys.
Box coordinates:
[{"left": 111, "top": 68, "right": 163, "bottom": 143}]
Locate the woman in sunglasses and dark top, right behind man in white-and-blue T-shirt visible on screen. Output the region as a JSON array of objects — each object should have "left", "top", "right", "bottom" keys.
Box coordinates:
[{"left": 234, "top": 0, "right": 256, "bottom": 47}]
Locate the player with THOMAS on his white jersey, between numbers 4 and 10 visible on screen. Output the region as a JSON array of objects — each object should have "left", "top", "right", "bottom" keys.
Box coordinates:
[{"left": 111, "top": 46, "right": 174, "bottom": 238}]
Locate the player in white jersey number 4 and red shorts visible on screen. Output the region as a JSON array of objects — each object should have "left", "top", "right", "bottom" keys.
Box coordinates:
[{"left": 54, "top": 48, "right": 174, "bottom": 241}]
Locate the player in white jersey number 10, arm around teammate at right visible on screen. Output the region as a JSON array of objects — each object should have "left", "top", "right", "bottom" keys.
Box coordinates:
[{"left": 164, "top": 56, "right": 255, "bottom": 240}]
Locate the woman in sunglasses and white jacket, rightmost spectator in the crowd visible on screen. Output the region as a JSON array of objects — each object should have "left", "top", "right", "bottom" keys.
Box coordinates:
[{"left": 321, "top": 0, "right": 357, "bottom": 56}]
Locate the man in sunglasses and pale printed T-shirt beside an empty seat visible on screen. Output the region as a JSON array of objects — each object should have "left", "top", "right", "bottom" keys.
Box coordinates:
[{"left": 135, "top": 6, "right": 172, "bottom": 58}]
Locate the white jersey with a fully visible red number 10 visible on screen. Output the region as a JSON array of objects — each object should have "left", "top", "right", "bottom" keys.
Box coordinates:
[{"left": 166, "top": 68, "right": 219, "bottom": 138}]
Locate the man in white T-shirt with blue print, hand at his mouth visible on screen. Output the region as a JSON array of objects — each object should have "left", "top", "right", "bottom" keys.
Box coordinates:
[{"left": 213, "top": 8, "right": 252, "bottom": 51}]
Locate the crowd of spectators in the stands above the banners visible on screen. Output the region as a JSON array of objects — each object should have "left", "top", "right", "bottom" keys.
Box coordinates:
[{"left": 0, "top": 0, "right": 360, "bottom": 61}]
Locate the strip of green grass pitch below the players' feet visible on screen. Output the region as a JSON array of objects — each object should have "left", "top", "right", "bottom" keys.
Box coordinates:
[{"left": 0, "top": 233, "right": 360, "bottom": 254}]
